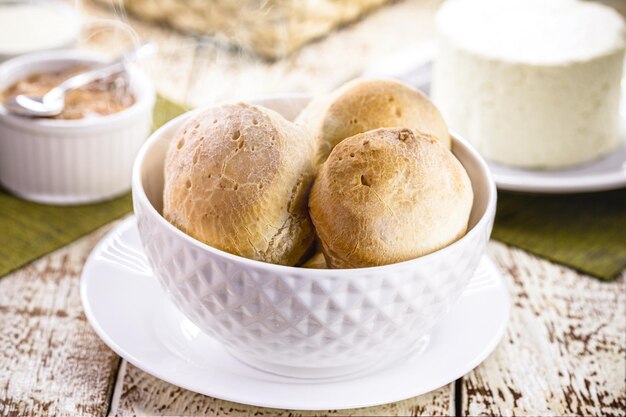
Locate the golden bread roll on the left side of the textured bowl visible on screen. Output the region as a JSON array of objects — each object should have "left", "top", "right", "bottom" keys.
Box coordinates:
[{"left": 163, "top": 103, "right": 314, "bottom": 265}]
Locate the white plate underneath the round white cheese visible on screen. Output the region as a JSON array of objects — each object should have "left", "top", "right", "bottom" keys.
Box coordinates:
[{"left": 364, "top": 53, "right": 626, "bottom": 193}]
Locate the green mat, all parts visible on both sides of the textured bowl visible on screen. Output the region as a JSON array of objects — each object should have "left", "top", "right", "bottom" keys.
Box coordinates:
[{"left": 0, "top": 98, "right": 626, "bottom": 280}]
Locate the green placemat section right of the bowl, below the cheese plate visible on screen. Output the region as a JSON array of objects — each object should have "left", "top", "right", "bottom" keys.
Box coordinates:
[{"left": 492, "top": 188, "right": 626, "bottom": 280}]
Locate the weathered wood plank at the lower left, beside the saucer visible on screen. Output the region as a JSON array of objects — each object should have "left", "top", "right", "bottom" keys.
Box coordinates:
[{"left": 0, "top": 219, "right": 120, "bottom": 416}]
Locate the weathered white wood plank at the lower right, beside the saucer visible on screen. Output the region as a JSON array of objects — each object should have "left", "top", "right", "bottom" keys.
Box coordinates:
[{"left": 462, "top": 243, "right": 626, "bottom": 416}]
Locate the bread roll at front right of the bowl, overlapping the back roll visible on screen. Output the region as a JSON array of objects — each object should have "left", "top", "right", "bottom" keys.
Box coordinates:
[{"left": 309, "top": 128, "right": 473, "bottom": 268}]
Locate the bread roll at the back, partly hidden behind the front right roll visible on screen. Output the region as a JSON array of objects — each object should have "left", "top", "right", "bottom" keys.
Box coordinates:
[{"left": 296, "top": 79, "right": 450, "bottom": 164}]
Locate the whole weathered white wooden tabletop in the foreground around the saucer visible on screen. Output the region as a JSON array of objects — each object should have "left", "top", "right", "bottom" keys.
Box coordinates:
[{"left": 0, "top": 226, "right": 626, "bottom": 416}]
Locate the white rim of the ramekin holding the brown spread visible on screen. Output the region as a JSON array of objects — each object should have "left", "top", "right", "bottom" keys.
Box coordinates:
[{"left": 0, "top": 49, "right": 156, "bottom": 129}]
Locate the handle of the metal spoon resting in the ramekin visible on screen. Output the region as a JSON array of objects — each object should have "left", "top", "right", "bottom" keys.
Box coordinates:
[{"left": 42, "top": 42, "right": 155, "bottom": 103}]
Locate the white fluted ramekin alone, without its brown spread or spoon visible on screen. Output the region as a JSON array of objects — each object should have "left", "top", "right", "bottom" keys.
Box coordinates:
[{"left": 0, "top": 50, "right": 155, "bottom": 204}]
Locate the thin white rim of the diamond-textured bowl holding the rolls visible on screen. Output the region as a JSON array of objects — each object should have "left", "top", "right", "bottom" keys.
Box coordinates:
[{"left": 132, "top": 93, "right": 497, "bottom": 278}]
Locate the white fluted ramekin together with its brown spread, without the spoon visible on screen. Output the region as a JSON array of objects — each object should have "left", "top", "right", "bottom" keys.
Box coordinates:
[{"left": 0, "top": 50, "right": 155, "bottom": 204}]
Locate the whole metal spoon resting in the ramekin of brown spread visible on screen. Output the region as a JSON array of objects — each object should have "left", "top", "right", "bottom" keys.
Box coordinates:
[{"left": 4, "top": 43, "right": 156, "bottom": 117}]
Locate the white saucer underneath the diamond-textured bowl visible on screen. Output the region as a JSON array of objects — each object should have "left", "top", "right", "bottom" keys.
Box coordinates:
[{"left": 81, "top": 217, "right": 510, "bottom": 410}]
